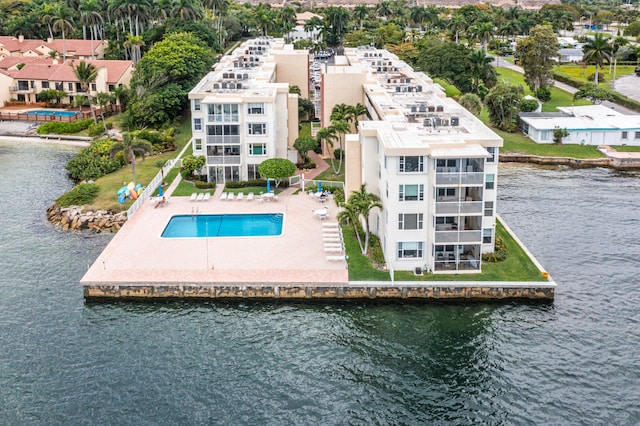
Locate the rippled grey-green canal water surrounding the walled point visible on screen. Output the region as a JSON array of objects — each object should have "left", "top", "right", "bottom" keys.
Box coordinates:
[{"left": 0, "top": 142, "right": 640, "bottom": 425}]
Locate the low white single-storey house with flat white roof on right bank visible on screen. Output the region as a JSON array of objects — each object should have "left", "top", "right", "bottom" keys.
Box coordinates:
[{"left": 520, "top": 105, "right": 640, "bottom": 146}]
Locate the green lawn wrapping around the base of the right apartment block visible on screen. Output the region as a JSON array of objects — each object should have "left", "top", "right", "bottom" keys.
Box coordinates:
[{"left": 343, "top": 220, "right": 546, "bottom": 281}]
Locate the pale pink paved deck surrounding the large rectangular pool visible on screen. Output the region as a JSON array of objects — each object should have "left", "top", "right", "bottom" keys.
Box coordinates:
[{"left": 81, "top": 190, "right": 349, "bottom": 285}]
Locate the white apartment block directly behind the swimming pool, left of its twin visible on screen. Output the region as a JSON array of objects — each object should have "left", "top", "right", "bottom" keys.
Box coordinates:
[{"left": 189, "top": 37, "right": 309, "bottom": 183}]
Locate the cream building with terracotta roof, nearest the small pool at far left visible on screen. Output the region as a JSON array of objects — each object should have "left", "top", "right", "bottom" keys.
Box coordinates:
[{"left": 0, "top": 56, "right": 133, "bottom": 103}]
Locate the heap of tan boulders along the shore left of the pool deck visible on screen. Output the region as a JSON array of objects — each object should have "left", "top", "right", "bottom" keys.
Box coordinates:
[{"left": 47, "top": 203, "right": 127, "bottom": 233}]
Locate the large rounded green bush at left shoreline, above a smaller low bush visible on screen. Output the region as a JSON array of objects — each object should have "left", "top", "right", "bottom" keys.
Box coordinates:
[{"left": 65, "top": 139, "right": 125, "bottom": 181}]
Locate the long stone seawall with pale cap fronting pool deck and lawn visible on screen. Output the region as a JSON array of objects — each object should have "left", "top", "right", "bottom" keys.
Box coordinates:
[{"left": 83, "top": 281, "right": 556, "bottom": 300}]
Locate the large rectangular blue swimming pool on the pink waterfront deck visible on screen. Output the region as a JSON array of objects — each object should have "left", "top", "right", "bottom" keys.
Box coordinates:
[{"left": 162, "top": 213, "right": 284, "bottom": 238}]
